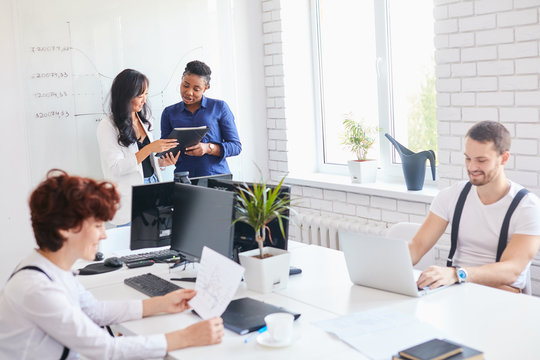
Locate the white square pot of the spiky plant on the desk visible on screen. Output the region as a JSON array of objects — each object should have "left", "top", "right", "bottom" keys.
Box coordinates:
[{"left": 238, "top": 247, "right": 291, "bottom": 293}]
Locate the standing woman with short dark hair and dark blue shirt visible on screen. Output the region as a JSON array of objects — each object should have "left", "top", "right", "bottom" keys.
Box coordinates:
[{"left": 161, "top": 60, "right": 242, "bottom": 177}]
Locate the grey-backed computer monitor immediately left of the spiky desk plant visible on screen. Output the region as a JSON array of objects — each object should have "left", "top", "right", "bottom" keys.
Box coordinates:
[{"left": 171, "top": 183, "right": 235, "bottom": 261}]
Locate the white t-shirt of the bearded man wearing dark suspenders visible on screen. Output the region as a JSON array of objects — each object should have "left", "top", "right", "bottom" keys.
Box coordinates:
[{"left": 430, "top": 181, "right": 540, "bottom": 289}]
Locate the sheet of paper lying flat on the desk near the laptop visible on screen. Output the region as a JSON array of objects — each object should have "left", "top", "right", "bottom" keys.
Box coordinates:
[{"left": 315, "top": 308, "right": 446, "bottom": 360}]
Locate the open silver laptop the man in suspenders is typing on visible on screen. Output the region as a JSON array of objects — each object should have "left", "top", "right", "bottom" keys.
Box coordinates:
[{"left": 338, "top": 231, "right": 447, "bottom": 297}]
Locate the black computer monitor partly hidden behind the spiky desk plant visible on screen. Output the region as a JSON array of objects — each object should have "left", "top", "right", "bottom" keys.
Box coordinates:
[{"left": 208, "top": 179, "right": 291, "bottom": 254}]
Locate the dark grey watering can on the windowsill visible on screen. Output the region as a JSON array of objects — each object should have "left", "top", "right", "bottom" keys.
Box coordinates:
[{"left": 384, "top": 134, "right": 436, "bottom": 190}]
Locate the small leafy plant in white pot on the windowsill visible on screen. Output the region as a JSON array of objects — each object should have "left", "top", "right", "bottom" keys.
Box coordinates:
[{"left": 342, "top": 113, "right": 377, "bottom": 183}]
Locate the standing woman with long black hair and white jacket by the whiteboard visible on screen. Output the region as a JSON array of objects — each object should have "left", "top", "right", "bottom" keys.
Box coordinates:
[{"left": 97, "top": 69, "right": 178, "bottom": 225}]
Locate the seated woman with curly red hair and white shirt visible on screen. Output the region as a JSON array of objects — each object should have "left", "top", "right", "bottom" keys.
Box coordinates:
[{"left": 0, "top": 170, "right": 224, "bottom": 359}]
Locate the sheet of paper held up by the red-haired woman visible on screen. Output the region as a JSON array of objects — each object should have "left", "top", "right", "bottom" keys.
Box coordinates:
[{"left": 189, "top": 246, "right": 244, "bottom": 319}]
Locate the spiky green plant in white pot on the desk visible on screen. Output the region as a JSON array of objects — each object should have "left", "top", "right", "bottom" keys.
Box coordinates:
[{"left": 235, "top": 173, "right": 291, "bottom": 293}]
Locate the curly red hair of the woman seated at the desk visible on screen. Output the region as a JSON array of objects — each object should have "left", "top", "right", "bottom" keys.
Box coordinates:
[{"left": 29, "top": 169, "right": 120, "bottom": 251}]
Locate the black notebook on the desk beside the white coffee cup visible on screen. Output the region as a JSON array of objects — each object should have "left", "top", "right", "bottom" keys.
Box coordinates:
[{"left": 217, "top": 297, "right": 300, "bottom": 335}]
